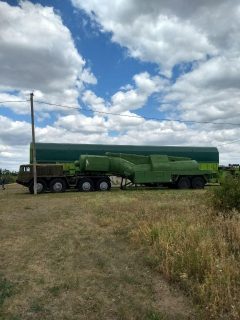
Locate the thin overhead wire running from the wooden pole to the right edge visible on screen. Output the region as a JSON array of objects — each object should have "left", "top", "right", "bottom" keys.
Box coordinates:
[{"left": 35, "top": 100, "right": 240, "bottom": 126}]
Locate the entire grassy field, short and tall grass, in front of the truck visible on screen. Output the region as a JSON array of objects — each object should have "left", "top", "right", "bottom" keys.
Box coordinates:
[{"left": 0, "top": 185, "right": 240, "bottom": 320}]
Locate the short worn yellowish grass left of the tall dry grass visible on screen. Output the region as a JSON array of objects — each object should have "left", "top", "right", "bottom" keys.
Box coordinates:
[{"left": 0, "top": 185, "right": 197, "bottom": 320}]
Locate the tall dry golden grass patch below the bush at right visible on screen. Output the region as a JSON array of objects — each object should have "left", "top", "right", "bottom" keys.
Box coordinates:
[{"left": 133, "top": 192, "right": 240, "bottom": 319}]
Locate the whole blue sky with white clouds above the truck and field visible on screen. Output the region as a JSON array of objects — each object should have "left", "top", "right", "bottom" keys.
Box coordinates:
[{"left": 0, "top": 0, "right": 240, "bottom": 170}]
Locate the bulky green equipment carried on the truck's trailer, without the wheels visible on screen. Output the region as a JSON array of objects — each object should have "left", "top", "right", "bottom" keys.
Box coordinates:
[{"left": 78, "top": 153, "right": 210, "bottom": 184}]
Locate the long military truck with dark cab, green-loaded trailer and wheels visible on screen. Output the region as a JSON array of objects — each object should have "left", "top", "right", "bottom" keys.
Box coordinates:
[{"left": 17, "top": 153, "right": 214, "bottom": 193}]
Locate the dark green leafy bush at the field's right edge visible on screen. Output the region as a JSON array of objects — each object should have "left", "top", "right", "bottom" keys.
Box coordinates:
[{"left": 211, "top": 176, "right": 240, "bottom": 213}]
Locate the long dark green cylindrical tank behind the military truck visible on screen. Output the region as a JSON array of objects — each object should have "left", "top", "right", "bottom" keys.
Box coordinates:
[{"left": 30, "top": 143, "right": 219, "bottom": 170}]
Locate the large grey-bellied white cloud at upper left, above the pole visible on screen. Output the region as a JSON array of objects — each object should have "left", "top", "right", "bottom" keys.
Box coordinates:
[{"left": 0, "top": 1, "right": 97, "bottom": 113}]
